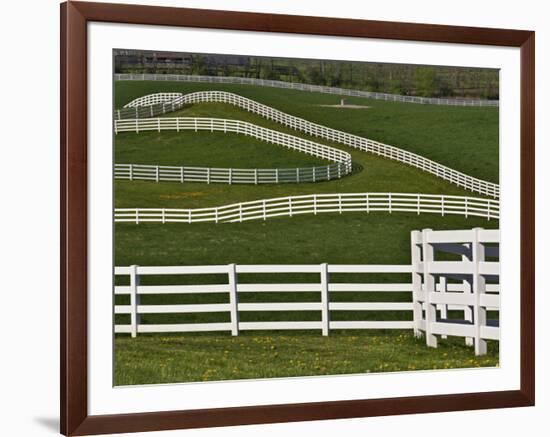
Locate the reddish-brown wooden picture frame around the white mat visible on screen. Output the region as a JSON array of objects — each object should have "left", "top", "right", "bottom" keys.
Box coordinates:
[{"left": 60, "top": 2, "right": 535, "bottom": 436}]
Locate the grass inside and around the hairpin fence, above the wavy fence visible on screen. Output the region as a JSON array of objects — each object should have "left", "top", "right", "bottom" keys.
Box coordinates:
[{"left": 115, "top": 103, "right": 488, "bottom": 208}]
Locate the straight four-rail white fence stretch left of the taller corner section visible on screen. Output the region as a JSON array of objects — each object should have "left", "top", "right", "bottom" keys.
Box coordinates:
[{"left": 115, "top": 264, "right": 413, "bottom": 337}]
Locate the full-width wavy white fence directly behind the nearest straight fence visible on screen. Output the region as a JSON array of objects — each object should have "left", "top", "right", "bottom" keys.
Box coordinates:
[{"left": 115, "top": 193, "right": 499, "bottom": 224}]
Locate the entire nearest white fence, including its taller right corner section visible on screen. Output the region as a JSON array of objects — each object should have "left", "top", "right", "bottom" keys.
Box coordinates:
[{"left": 115, "top": 228, "right": 500, "bottom": 355}]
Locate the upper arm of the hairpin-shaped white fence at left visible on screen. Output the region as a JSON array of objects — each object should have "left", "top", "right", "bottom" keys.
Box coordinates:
[{"left": 115, "top": 117, "right": 352, "bottom": 174}]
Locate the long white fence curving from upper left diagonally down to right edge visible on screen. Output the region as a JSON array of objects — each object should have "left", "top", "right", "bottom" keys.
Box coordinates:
[{"left": 115, "top": 91, "right": 500, "bottom": 198}]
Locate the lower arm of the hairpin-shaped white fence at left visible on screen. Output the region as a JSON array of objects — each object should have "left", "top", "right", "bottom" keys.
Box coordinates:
[{"left": 115, "top": 162, "right": 348, "bottom": 184}]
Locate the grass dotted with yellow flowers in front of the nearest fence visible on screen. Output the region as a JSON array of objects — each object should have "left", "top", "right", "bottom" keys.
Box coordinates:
[{"left": 115, "top": 331, "right": 498, "bottom": 385}]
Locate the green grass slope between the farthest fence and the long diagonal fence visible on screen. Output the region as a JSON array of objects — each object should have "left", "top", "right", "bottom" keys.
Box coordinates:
[{"left": 115, "top": 81, "right": 499, "bottom": 182}]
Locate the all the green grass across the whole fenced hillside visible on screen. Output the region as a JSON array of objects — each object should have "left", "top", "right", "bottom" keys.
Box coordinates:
[{"left": 114, "top": 82, "right": 498, "bottom": 385}]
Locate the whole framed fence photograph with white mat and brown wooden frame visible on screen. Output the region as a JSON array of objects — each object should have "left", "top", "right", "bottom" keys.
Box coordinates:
[{"left": 61, "top": 2, "right": 535, "bottom": 435}]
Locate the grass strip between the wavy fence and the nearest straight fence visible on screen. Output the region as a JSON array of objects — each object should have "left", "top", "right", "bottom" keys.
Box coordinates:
[{"left": 115, "top": 213, "right": 498, "bottom": 266}]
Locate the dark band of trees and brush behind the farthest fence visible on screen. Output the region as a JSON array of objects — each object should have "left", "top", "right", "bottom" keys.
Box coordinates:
[{"left": 115, "top": 51, "right": 499, "bottom": 99}]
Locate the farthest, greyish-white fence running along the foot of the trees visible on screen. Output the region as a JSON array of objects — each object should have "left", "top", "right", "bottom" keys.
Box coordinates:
[{"left": 115, "top": 74, "right": 499, "bottom": 107}]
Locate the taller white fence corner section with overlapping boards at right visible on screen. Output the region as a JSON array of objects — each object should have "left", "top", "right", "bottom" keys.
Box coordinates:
[{"left": 411, "top": 228, "right": 500, "bottom": 355}]
